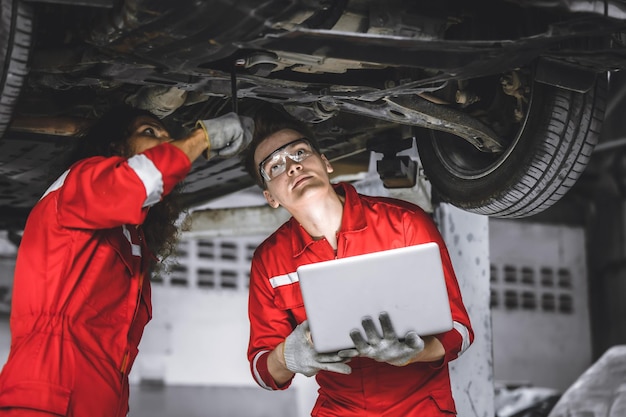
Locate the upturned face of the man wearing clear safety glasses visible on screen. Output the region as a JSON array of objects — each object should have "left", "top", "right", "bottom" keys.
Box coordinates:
[{"left": 254, "top": 129, "right": 333, "bottom": 209}]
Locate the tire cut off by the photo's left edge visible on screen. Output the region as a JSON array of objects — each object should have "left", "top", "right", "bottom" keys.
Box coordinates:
[{"left": 0, "top": 0, "right": 32, "bottom": 137}]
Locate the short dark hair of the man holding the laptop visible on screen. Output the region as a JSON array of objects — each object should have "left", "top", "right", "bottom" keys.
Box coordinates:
[{"left": 240, "top": 106, "right": 321, "bottom": 189}]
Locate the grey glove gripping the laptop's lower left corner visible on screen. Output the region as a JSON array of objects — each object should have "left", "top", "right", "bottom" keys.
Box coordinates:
[{"left": 284, "top": 320, "right": 358, "bottom": 376}]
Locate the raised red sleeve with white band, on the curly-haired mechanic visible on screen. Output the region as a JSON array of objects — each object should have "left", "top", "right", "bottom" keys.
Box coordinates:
[{"left": 53, "top": 143, "right": 191, "bottom": 229}]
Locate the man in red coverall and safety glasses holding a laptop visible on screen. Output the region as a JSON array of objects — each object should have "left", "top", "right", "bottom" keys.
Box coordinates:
[{"left": 245, "top": 108, "right": 474, "bottom": 417}]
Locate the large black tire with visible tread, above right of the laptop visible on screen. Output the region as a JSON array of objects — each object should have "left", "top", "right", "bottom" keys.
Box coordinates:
[{"left": 417, "top": 75, "right": 607, "bottom": 218}]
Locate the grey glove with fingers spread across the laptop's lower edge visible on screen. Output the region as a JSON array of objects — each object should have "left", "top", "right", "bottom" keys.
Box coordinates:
[{"left": 339, "top": 312, "right": 424, "bottom": 366}]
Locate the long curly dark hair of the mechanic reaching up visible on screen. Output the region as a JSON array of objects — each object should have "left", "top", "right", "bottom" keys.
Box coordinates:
[{"left": 70, "top": 105, "right": 183, "bottom": 259}]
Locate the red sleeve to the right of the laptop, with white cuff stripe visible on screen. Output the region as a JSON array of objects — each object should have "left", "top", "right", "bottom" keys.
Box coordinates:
[{"left": 405, "top": 210, "right": 474, "bottom": 366}]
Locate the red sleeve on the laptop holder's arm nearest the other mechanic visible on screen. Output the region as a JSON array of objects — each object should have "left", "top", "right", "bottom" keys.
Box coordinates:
[{"left": 248, "top": 251, "right": 300, "bottom": 390}]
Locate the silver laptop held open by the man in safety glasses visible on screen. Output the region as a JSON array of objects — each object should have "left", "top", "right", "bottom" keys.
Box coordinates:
[{"left": 297, "top": 242, "right": 452, "bottom": 352}]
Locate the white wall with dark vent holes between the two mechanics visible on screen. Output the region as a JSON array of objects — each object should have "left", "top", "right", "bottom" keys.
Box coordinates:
[{"left": 130, "top": 236, "right": 262, "bottom": 386}]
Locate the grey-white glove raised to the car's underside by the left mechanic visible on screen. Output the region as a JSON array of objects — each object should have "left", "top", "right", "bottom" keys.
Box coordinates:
[{"left": 196, "top": 112, "right": 254, "bottom": 159}]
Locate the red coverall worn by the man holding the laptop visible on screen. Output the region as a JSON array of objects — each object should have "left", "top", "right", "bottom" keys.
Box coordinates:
[{"left": 248, "top": 184, "right": 474, "bottom": 417}]
